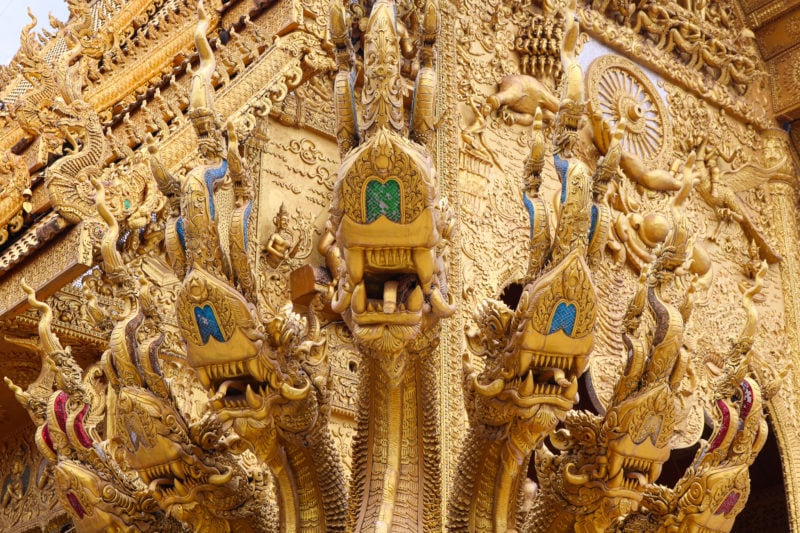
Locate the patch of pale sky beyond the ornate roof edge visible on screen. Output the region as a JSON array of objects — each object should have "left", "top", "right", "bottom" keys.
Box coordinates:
[{"left": 0, "top": 0, "right": 69, "bottom": 65}]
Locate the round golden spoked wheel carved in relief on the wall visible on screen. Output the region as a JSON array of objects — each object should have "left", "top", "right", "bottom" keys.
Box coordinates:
[{"left": 586, "top": 55, "right": 672, "bottom": 168}]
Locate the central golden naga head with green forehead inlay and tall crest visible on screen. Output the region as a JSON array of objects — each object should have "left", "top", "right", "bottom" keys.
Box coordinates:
[{"left": 323, "top": 0, "right": 454, "bottom": 364}]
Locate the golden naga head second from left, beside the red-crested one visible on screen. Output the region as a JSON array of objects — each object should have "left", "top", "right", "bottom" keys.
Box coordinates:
[{"left": 111, "top": 387, "right": 276, "bottom": 531}]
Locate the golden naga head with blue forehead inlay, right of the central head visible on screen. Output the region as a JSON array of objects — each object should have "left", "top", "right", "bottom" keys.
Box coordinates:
[{"left": 465, "top": 250, "right": 596, "bottom": 432}]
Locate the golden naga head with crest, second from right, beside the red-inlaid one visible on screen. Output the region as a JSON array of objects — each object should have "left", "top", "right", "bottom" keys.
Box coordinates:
[{"left": 551, "top": 261, "right": 686, "bottom": 528}]
